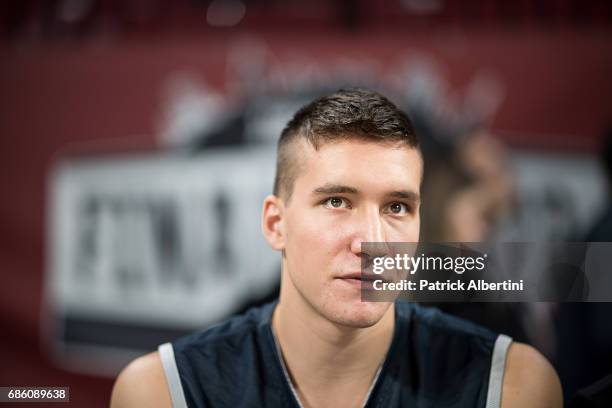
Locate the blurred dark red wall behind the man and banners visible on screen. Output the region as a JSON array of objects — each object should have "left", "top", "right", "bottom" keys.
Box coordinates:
[{"left": 0, "top": 1, "right": 612, "bottom": 406}]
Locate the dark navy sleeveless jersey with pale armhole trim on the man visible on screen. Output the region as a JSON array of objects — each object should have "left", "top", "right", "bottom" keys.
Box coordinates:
[{"left": 159, "top": 301, "right": 511, "bottom": 408}]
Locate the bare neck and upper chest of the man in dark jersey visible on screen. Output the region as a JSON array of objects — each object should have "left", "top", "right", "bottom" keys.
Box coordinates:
[{"left": 272, "top": 276, "right": 395, "bottom": 404}]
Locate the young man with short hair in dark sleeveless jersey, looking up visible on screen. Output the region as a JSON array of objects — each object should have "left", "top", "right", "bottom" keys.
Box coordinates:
[{"left": 111, "top": 90, "right": 562, "bottom": 407}]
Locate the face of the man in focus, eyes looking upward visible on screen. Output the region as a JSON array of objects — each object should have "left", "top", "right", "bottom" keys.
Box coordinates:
[{"left": 284, "top": 140, "right": 422, "bottom": 327}]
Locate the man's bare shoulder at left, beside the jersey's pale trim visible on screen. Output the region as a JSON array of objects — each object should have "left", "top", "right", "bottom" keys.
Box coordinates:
[{"left": 110, "top": 352, "right": 172, "bottom": 408}]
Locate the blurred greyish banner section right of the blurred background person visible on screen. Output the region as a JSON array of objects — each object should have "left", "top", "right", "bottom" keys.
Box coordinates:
[{"left": 502, "top": 149, "right": 607, "bottom": 242}]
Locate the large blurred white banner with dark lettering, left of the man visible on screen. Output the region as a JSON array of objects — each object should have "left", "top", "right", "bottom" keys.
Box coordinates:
[{"left": 44, "top": 148, "right": 280, "bottom": 371}]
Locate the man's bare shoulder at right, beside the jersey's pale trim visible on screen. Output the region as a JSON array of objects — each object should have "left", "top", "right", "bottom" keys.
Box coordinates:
[{"left": 502, "top": 343, "right": 563, "bottom": 408}]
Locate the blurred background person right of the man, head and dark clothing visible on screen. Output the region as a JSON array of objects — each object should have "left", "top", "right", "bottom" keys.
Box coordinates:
[{"left": 421, "top": 130, "right": 528, "bottom": 341}]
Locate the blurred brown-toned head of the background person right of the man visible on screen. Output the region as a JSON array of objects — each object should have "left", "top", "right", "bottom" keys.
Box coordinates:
[{"left": 422, "top": 131, "right": 514, "bottom": 242}]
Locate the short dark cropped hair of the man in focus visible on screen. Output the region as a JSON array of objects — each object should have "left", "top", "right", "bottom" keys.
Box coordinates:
[{"left": 274, "top": 89, "right": 419, "bottom": 200}]
